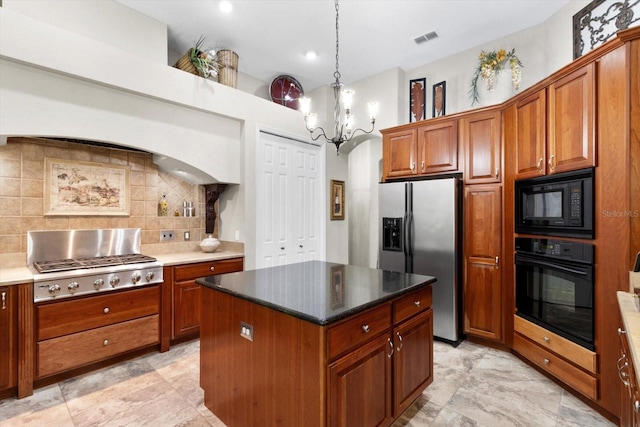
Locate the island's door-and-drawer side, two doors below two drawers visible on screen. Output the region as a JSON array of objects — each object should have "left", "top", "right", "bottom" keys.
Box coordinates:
[{"left": 327, "top": 286, "right": 433, "bottom": 426}]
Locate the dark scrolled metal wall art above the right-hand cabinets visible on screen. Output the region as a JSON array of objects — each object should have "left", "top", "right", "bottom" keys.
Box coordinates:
[{"left": 573, "top": 0, "right": 640, "bottom": 59}]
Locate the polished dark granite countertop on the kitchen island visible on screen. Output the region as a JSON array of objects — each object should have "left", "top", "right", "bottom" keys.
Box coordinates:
[{"left": 196, "top": 261, "right": 436, "bottom": 325}]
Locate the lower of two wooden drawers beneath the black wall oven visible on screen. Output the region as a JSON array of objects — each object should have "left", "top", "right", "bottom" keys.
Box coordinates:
[{"left": 513, "top": 333, "right": 598, "bottom": 400}]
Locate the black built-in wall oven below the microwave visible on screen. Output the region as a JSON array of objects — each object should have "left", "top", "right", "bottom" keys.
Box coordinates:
[{"left": 515, "top": 237, "right": 595, "bottom": 351}]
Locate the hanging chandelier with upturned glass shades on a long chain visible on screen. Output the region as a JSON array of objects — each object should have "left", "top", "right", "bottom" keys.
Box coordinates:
[{"left": 300, "top": 0, "right": 378, "bottom": 154}]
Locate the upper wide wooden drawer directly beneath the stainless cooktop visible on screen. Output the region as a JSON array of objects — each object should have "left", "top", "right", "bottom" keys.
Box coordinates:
[{"left": 36, "top": 285, "right": 160, "bottom": 341}]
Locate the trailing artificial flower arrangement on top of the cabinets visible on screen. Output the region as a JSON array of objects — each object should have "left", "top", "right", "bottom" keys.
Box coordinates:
[{"left": 471, "top": 49, "right": 523, "bottom": 105}]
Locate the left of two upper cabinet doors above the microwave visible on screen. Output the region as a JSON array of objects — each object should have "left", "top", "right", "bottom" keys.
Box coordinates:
[{"left": 515, "top": 89, "right": 547, "bottom": 179}]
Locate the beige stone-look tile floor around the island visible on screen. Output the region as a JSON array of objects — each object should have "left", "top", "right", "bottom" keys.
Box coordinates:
[{"left": 0, "top": 341, "right": 614, "bottom": 427}]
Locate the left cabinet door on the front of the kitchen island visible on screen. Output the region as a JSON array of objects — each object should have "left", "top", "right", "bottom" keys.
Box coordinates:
[{"left": 327, "top": 334, "right": 393, "bottom": 427}]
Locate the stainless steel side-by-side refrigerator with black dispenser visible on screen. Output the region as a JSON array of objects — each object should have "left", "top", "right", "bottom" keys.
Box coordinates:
[{"left": 379, "top": 177, "right": 461, "bottom": 345}]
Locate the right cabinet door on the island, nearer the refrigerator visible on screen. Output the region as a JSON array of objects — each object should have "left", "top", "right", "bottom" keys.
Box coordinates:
[{"left": 393, "top": 309, "right": 433, "bottom": 417}]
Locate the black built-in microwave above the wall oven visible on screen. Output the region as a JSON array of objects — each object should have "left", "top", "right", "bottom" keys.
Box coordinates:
[{"left": 514, "top": 168, "right": 594, "bottom": 239}]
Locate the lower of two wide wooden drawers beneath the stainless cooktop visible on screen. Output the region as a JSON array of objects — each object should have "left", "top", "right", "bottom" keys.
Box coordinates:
[{"left": 36, "top": 314, "right": 160, "bottom": 378}]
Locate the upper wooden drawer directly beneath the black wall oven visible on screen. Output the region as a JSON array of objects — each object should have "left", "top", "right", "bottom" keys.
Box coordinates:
[{"left": 513, "top": 316, "right": 598, "bottom": 374}]
